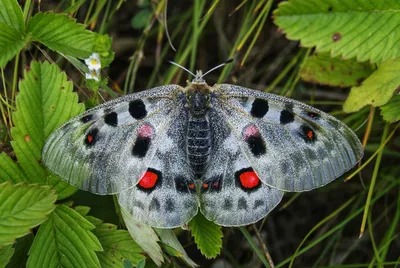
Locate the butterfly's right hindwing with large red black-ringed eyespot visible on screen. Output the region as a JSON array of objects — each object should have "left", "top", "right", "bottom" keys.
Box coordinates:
[{"left": 200, "top": 109, "right": 283, "bottom": 226}]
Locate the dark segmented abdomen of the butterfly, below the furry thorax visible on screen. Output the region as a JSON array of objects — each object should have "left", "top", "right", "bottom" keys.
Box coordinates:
[{"left": 187, "top": 116, "right": 211, "bottom": 176}]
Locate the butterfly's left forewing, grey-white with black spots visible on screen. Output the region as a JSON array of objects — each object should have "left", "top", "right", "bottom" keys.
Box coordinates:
[{"left": 42, "top": 85, "right": 187, "bottom": 194}]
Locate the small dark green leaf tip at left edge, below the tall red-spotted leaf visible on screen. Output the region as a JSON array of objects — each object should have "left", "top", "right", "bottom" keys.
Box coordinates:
[{"left": 0, "top": 152, "right": 29, "bottom": 183}]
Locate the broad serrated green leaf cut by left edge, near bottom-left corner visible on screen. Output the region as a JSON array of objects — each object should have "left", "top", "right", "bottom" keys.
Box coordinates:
[{"left": 0, "top": 182, "right": 57, "bottom": 245}]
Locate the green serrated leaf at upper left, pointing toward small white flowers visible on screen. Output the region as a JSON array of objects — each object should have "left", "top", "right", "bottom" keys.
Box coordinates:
[{"left": 27, "top": 12, "right": 94, "bottom": 58}]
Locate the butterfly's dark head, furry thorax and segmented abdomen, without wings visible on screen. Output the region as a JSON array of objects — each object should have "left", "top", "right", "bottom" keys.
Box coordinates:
[{"left": 185, "top": 76, "right": 212, "bottom": 178}]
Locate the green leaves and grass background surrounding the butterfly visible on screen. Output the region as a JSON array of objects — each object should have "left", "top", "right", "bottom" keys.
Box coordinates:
[{"left": 0, "top": 0, "right": 400, "bottom": 267}]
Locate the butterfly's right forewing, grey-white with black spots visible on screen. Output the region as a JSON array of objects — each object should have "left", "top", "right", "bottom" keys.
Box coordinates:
[{"left": 212, "top": 84, "right": 363, "bottom": 191}]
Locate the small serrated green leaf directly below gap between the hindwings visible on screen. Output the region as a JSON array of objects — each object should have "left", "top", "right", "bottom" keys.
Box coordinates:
[{"left": 189, "top": 213, "right": 223, "bottom": 259}]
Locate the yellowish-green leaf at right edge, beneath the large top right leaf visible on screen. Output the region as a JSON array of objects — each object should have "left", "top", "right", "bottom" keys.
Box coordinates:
[{"left": 343, "top": 60, "right": 400, "bottom": 113}]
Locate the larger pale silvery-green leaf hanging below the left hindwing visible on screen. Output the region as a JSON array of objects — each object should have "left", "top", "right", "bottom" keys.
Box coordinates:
[{"left": 121, "top": 207, "right": 164, "bottom": 266}]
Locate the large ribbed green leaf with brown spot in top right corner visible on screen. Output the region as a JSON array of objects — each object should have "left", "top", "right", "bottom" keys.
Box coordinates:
[{"left": 274, "top": 0, "right": 400, "bottom": 62}]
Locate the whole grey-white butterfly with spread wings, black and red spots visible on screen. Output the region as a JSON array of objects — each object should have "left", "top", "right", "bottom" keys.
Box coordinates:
[{"left": 43, "top": 74, "right": 363, "bottom": 228}]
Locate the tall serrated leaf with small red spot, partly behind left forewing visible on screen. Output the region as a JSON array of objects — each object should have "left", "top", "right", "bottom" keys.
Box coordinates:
[{"left": 11, "top": 62, "right": 84, "bottom": 199}]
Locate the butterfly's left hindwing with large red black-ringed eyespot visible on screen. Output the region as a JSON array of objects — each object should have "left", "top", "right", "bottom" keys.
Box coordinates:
[{"left": 118, "top": 110, "right": 199, "bottom": 228}]
